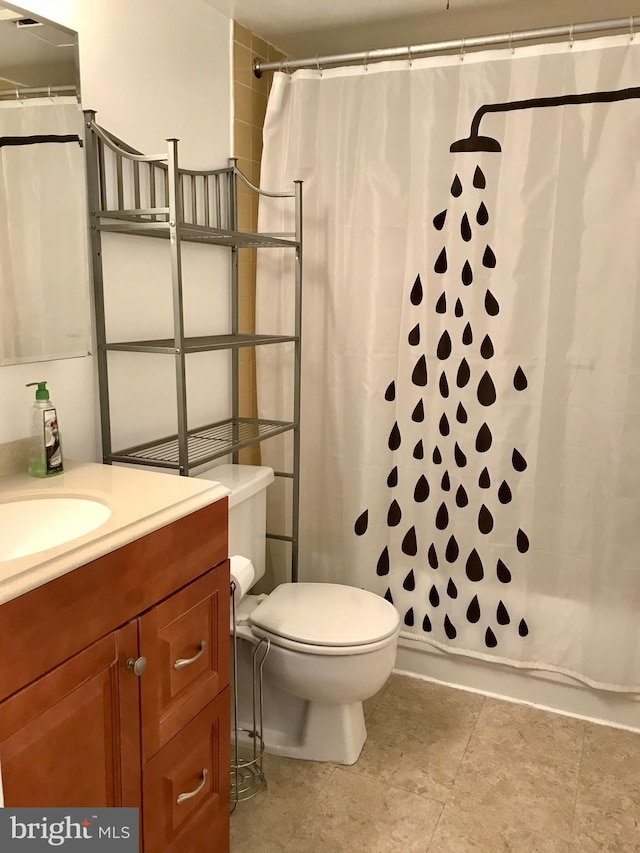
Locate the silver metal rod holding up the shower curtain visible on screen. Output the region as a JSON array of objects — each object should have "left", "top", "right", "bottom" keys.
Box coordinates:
[{"left": 253, "top": 15, "right": 640, "bottom": 77}]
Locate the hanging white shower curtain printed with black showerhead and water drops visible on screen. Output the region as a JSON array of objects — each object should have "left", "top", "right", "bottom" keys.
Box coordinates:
[{"left": 257, "top": 37, "right": 640, "bottom": 691}]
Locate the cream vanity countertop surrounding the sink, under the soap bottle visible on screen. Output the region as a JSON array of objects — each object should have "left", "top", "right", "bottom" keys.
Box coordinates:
[{"left": 0, "top": 460, "right": 229, "bottom": 604}]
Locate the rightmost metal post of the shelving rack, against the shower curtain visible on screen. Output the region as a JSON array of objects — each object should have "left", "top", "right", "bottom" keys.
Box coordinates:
[{"left": 291, "top": 181, "right": 302, "bottom": 583}]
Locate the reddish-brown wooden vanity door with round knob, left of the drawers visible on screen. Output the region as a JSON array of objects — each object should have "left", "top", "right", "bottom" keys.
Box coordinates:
[{"left": 0, "top": 622, "right": 141, "bottom": 808}]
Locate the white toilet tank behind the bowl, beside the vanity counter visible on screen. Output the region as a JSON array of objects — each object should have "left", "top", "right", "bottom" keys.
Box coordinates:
[{"left": 198, "top": 465, "right": 273, "bottom": 581}]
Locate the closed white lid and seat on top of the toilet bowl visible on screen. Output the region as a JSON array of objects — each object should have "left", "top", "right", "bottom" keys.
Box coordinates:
[{"left": 251, "top": 583, "right": 400, "bottom": 646}]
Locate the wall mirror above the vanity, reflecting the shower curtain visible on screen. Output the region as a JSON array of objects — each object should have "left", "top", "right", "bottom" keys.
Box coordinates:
[{"left": 0, "top": 0, "right": 91, "bottom": 365}]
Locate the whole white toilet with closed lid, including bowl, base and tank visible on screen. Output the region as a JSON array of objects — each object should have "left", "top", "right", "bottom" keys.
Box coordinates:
[{"left": 201, "top": 465, "right": 400, "bottom": 764}]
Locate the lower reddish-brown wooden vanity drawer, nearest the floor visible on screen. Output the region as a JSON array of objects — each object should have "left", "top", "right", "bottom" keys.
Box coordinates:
[{"left": 142, "top": 688, "right": 231, "bottom": 853}]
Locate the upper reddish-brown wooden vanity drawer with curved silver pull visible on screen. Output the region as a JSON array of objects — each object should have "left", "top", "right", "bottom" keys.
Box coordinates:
[{"left": 139, "top": 561, "right": 229, "bottom": 761}]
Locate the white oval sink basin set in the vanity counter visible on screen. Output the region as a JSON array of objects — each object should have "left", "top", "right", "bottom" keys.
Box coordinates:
[{"left": 0, "top": 497, "right": 111, "bottom": 561}]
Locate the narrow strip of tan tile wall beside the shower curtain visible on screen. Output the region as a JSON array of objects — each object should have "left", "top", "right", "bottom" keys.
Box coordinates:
[{"left": 233, "top": 22, "right": 284, "bottom": 465}]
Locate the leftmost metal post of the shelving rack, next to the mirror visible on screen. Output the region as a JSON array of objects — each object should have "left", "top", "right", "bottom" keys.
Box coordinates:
[{"left": 84, "top": 110, "right": 111, "bottom": 465}]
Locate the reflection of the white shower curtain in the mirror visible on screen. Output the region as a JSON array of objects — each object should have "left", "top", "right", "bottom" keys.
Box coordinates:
[{"left": 0, "top": 98, "right": 90, "bottom": 364}]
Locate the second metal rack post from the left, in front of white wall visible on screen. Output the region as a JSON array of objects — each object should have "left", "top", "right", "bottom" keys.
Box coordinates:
[{"left": 167, "top": 138, "right": 189, "bottom": 477}]
